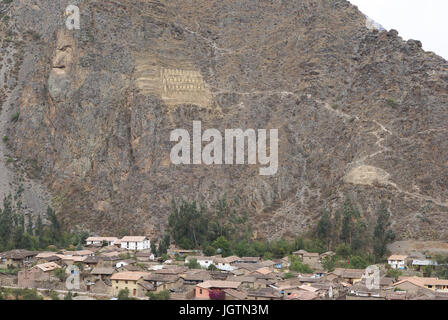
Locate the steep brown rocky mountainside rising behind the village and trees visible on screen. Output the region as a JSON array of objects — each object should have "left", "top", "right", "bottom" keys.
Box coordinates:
[{"left": 0, "top": 0, "right": 448, "bottom": 239}]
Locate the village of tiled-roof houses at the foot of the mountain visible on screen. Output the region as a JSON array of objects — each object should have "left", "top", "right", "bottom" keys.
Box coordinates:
[{"left": 0, "top": 236, "right": 448, "bottom": 300}]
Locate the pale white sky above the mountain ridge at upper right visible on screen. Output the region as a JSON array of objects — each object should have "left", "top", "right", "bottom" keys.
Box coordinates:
[{"left": 349, "top": 0, "right": 448, "bottom": 59}]
